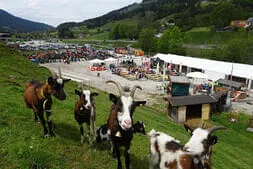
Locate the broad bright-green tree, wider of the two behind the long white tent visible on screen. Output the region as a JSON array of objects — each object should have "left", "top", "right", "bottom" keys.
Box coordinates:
[{"left": 158, "top": 26, "right": 185, "bottom": 55}]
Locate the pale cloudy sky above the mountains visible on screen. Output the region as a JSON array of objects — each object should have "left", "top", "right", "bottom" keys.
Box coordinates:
[{"left": 0, "top": 0, "right": 142, "bottom": 26}]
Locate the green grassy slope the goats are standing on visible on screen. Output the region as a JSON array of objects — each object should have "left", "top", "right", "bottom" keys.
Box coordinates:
[{"left": 0, "top": 44, "right": 253, "bottom": 169}]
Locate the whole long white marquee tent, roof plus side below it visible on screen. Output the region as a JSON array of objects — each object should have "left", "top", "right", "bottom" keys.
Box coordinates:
[{"left": 154, "top": 54, "right": 253, "bottom": 89}]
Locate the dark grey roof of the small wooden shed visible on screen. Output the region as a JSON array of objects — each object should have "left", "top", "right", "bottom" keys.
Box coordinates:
[{"left": 170, "top": 95, "right": 217, "bottom": 106}]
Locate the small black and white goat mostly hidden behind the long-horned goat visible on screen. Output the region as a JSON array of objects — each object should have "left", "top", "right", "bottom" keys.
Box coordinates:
[{"left": 96, "top": 121, "right": 146, "bottom": 143}]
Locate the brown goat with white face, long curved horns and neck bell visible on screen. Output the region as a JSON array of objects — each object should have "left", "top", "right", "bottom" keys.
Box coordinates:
[{"left": 106, "top": 81, "right": 146, "bottom": 169}]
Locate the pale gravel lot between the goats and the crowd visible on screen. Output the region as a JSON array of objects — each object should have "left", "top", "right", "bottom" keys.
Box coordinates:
[{"left": 41, "top": 61, "right": 167, "bottom": 104}]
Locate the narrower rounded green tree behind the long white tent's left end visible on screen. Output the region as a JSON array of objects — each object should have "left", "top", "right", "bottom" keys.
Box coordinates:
[{"left": 138, "top": 28, "right": 156, "bottom": 52}]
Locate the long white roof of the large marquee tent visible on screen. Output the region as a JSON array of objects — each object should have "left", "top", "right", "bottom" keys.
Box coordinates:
[{"left": 154, "top": 53, "right": 253, "bottom": 79}]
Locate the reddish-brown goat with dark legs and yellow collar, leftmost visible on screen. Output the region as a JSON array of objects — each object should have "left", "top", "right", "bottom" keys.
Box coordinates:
[{"left": 24, "top": 69, "right": 70, "bottom": 137}]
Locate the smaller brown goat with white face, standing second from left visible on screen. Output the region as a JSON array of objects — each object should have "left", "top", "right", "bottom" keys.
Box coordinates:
[{"left": 74, "top": 90, "right": 98, "bottom": 144}]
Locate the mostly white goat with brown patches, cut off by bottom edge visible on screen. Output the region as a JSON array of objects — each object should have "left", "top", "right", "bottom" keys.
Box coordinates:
[{"left": 148, "top": 127, "right": 224, "bottom": 169}]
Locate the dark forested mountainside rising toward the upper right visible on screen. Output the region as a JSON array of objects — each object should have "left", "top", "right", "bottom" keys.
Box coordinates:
[{"left": 57, "top": 0, "right": 253, "bottom": 30}]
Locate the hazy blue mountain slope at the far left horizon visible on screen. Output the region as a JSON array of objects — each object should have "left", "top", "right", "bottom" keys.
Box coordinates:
[{"left": 0, "top": 9, "right": 53, "bottom": 32}]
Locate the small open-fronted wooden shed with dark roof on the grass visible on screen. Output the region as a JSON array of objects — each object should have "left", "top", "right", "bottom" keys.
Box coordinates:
[{"left": 168, "top": 95, "right": 217, "bottom": 123}]
